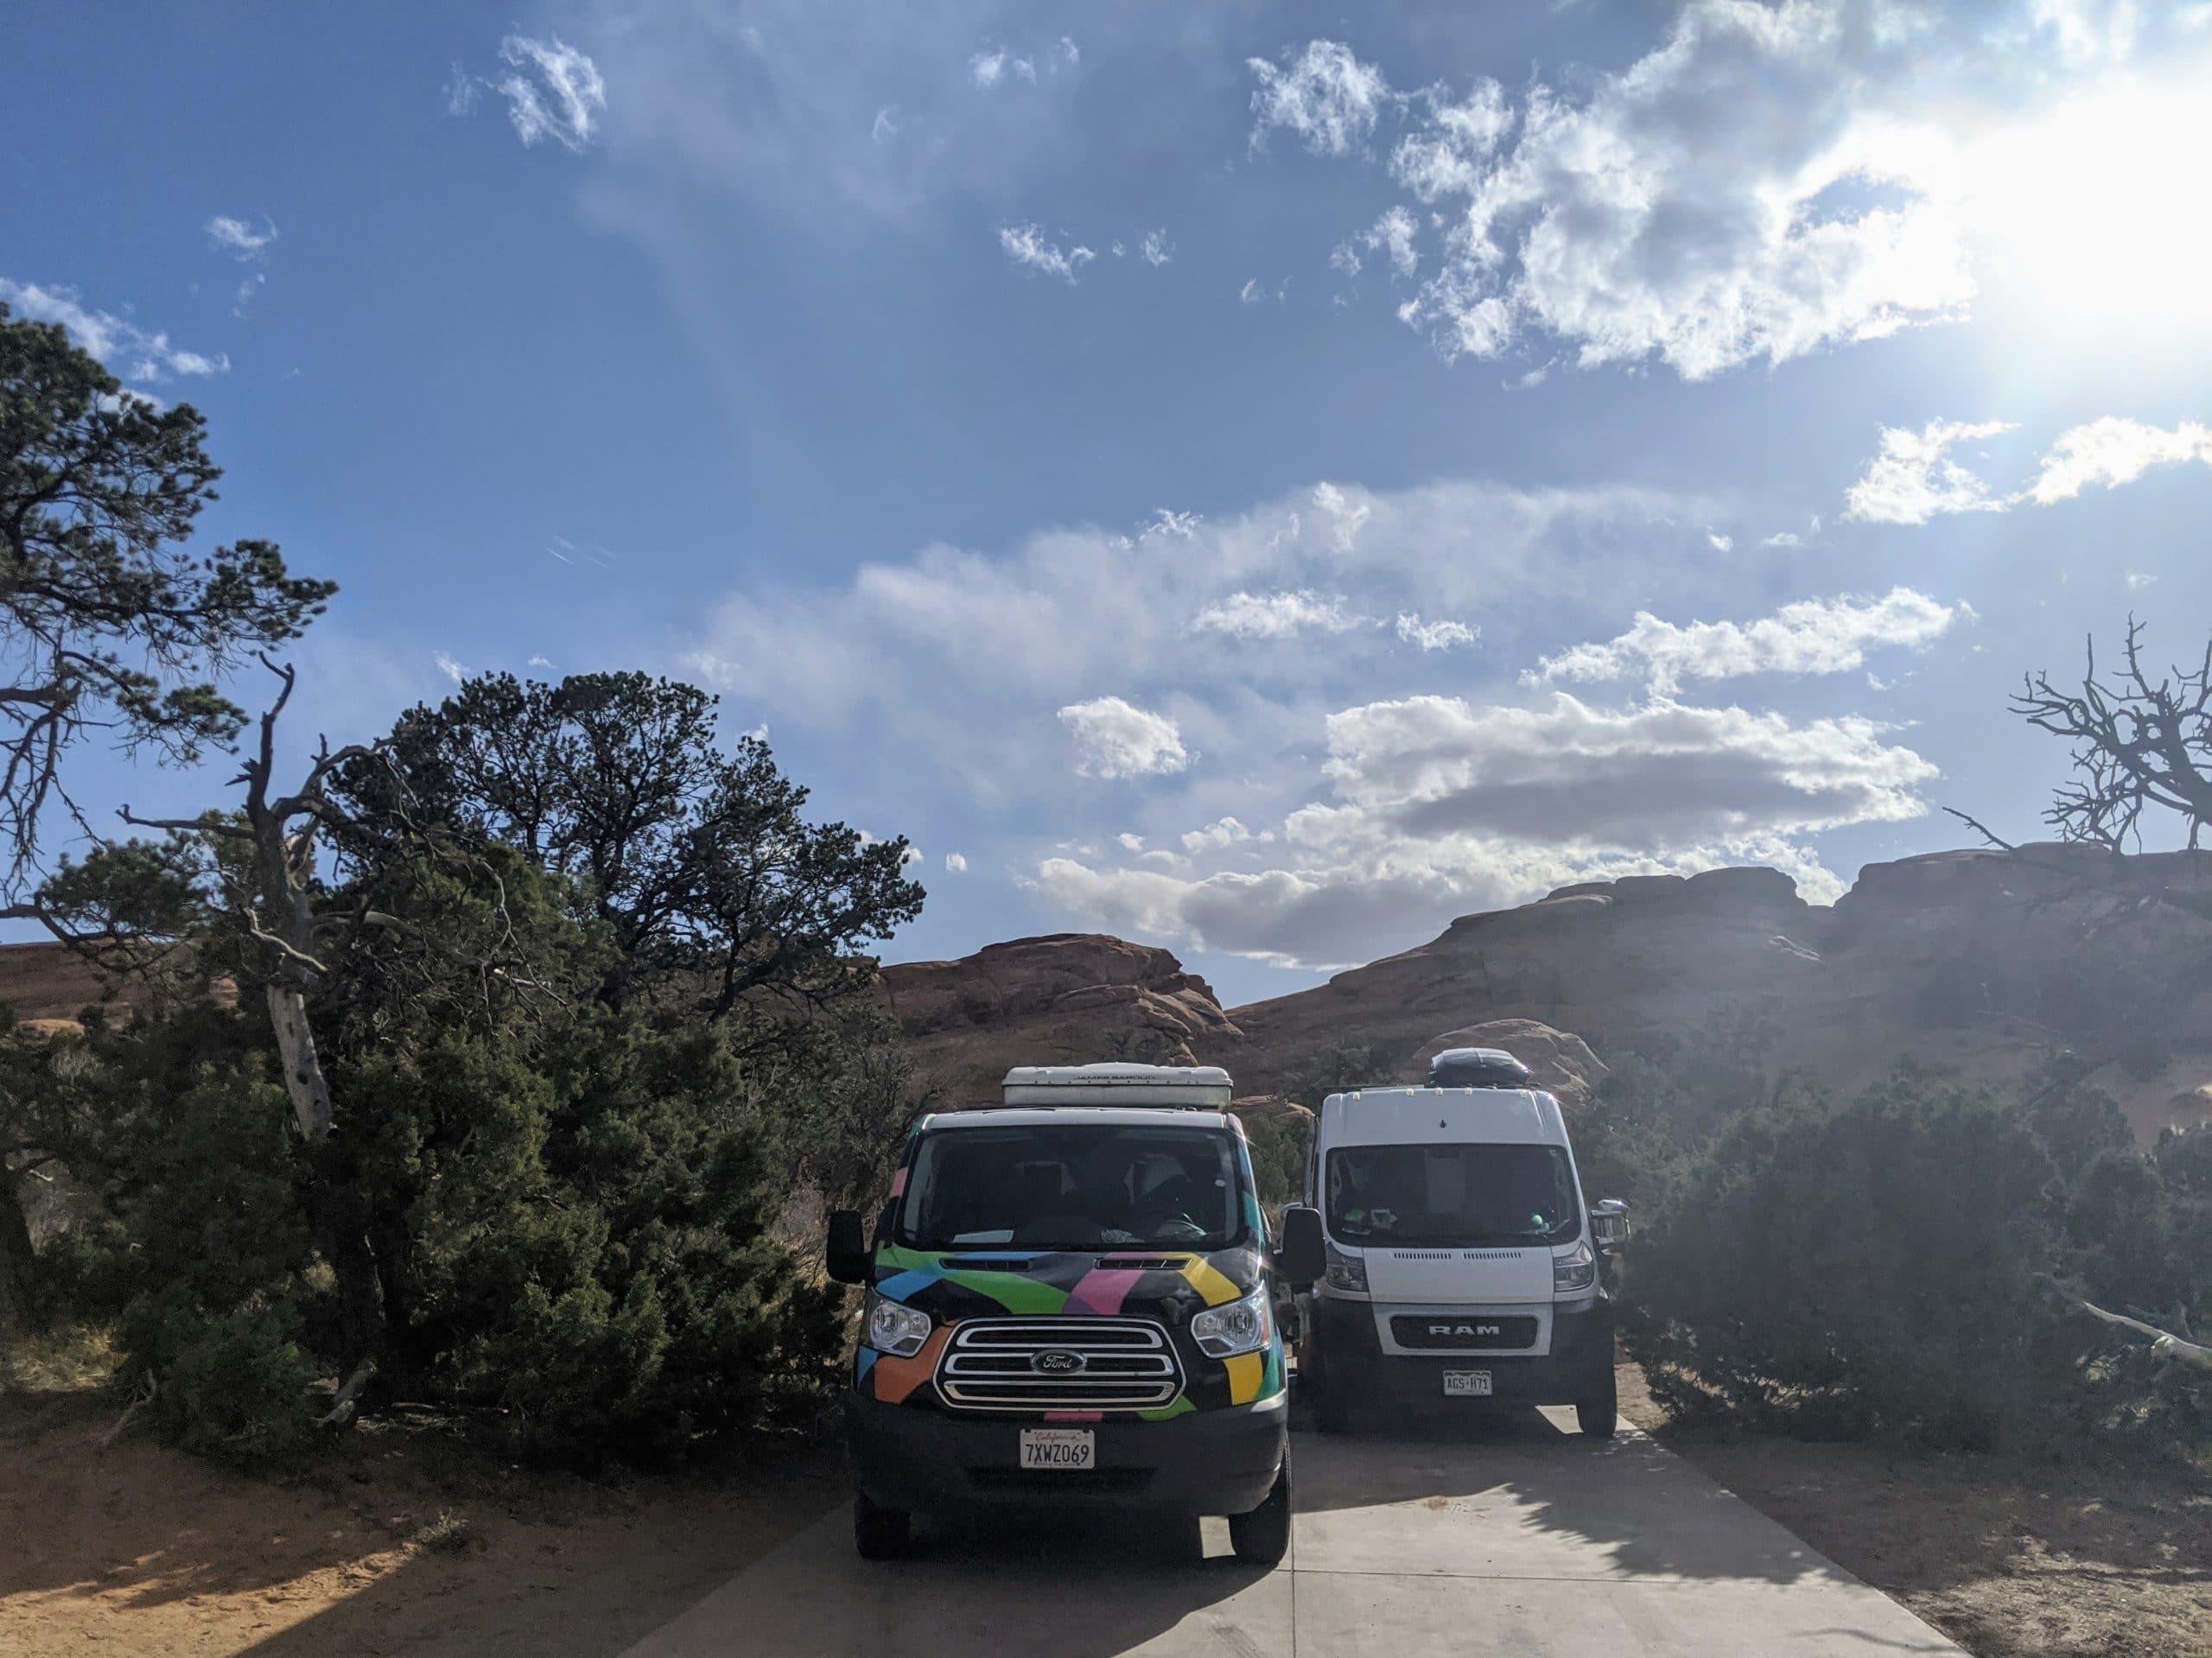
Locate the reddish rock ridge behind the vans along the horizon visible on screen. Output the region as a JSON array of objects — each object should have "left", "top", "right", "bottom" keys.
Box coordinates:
[{"left": 882, "top": 847, "right": 2212, "bottom": 1139}]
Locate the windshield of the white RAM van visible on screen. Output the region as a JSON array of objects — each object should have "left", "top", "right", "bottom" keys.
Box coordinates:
[{"left": 1327, "top": 1145, "right": 1581, "bottom": 1247}]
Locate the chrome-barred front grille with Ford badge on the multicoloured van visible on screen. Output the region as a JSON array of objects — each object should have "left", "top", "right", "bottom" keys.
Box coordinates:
[{"left": 938, "top": 1318, "right": 1184, "bottom": 1410}]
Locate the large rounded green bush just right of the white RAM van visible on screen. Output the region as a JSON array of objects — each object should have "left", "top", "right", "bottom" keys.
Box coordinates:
[{"left": 1630, "top": 1083, "right": 2082, "bottom": 1445}]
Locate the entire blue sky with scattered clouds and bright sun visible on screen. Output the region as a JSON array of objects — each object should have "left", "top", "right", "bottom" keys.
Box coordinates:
[{"left": 0, "top": 0, "right": 2212, "bottom": 1001}]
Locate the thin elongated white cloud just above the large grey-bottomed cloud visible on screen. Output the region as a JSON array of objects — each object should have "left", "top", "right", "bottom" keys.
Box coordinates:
[{"left": 1526, "top": 588, "right": 1974, "bottom": 696}]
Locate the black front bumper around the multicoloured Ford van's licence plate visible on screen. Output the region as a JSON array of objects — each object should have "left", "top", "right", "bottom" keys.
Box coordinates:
[{"left": 845, "top": 1393, "right": 1289, "bottom": 1515}]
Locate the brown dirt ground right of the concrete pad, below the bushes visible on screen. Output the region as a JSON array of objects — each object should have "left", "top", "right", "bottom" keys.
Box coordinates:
[{"left": 1621, "top": 1366, "right": 2212, "bottom": 1658}]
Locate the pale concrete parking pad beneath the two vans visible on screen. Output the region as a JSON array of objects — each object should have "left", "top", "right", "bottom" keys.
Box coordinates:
[{"left": 631, "top": 1413, "right": 1960, "bottom": 1658}]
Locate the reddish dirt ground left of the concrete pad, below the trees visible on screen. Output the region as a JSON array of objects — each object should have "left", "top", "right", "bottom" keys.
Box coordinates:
[{"left": 0, "top": 1395, "right": 842, "bottom": 1658}]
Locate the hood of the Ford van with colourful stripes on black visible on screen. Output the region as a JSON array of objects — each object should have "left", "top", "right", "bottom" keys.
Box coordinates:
[{"left": 876, "top": 1245, "right": 1265, "bottom": 1329}]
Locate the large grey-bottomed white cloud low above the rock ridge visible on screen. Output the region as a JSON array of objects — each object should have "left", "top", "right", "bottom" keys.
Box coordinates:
[{"left": 1035, "top": 694, "right": 1936, "bottom": 969}]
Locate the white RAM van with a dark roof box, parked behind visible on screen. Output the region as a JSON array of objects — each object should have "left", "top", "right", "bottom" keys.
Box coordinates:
[{"left": 1285, "top": 1048, "right": 1628, "bottom": 1435}]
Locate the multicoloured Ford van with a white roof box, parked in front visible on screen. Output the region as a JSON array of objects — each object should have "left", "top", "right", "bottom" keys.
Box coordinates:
[{"left": 830, "top": 1065, "right": 1323, "bottom": 1563}]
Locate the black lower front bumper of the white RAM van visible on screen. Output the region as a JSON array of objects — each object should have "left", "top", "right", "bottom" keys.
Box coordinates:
[{"left": 1299, "top": 1295, "right": 1612, "bottom": 1408}]
